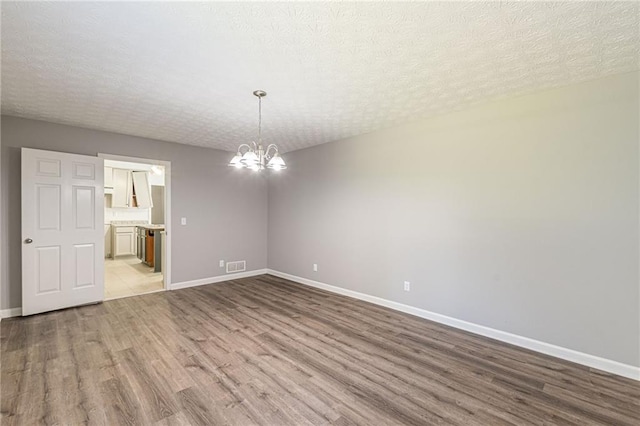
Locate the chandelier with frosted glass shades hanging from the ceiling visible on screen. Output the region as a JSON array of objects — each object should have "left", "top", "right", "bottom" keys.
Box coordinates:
[{"left": 229, "top": 90, "right": 287, "bottom": 171}]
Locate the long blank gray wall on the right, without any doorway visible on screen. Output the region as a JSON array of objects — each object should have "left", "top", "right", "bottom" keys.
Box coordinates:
[{"left": 268, "top": 73, "right": 640, "bottom": 366}]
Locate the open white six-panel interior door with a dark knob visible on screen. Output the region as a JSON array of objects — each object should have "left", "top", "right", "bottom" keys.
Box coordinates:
[{"left": 22, "top": 148, "right": 104, "bottom": 315}]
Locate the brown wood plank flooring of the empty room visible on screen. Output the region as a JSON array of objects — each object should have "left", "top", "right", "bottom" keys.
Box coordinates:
[{"left": 0, "top": 275, "right": 640, "bottom": 426}]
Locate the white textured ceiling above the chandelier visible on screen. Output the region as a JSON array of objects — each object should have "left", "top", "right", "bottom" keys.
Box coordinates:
[{"left": 2, "top": 2, "right": 640, "bottom": 151}]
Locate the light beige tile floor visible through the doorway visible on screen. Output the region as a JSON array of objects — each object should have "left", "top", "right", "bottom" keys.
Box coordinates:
[{"left": 104, "top": 256, "right": 164, "bottom": 299}]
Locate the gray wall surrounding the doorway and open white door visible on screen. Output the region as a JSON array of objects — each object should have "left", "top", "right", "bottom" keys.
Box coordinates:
[{"left": 0, "top": 116, "right": 267, "bottom": 309}]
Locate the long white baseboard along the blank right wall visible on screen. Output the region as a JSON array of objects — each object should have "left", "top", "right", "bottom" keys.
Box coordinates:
[{"left": 267, "top": 269, "right": 640, "bottom": 380}]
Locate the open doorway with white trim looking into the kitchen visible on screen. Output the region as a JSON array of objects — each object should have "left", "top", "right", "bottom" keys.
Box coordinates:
[{"left": 98, "top": 154, "right": 171, "bottom": 300}]
